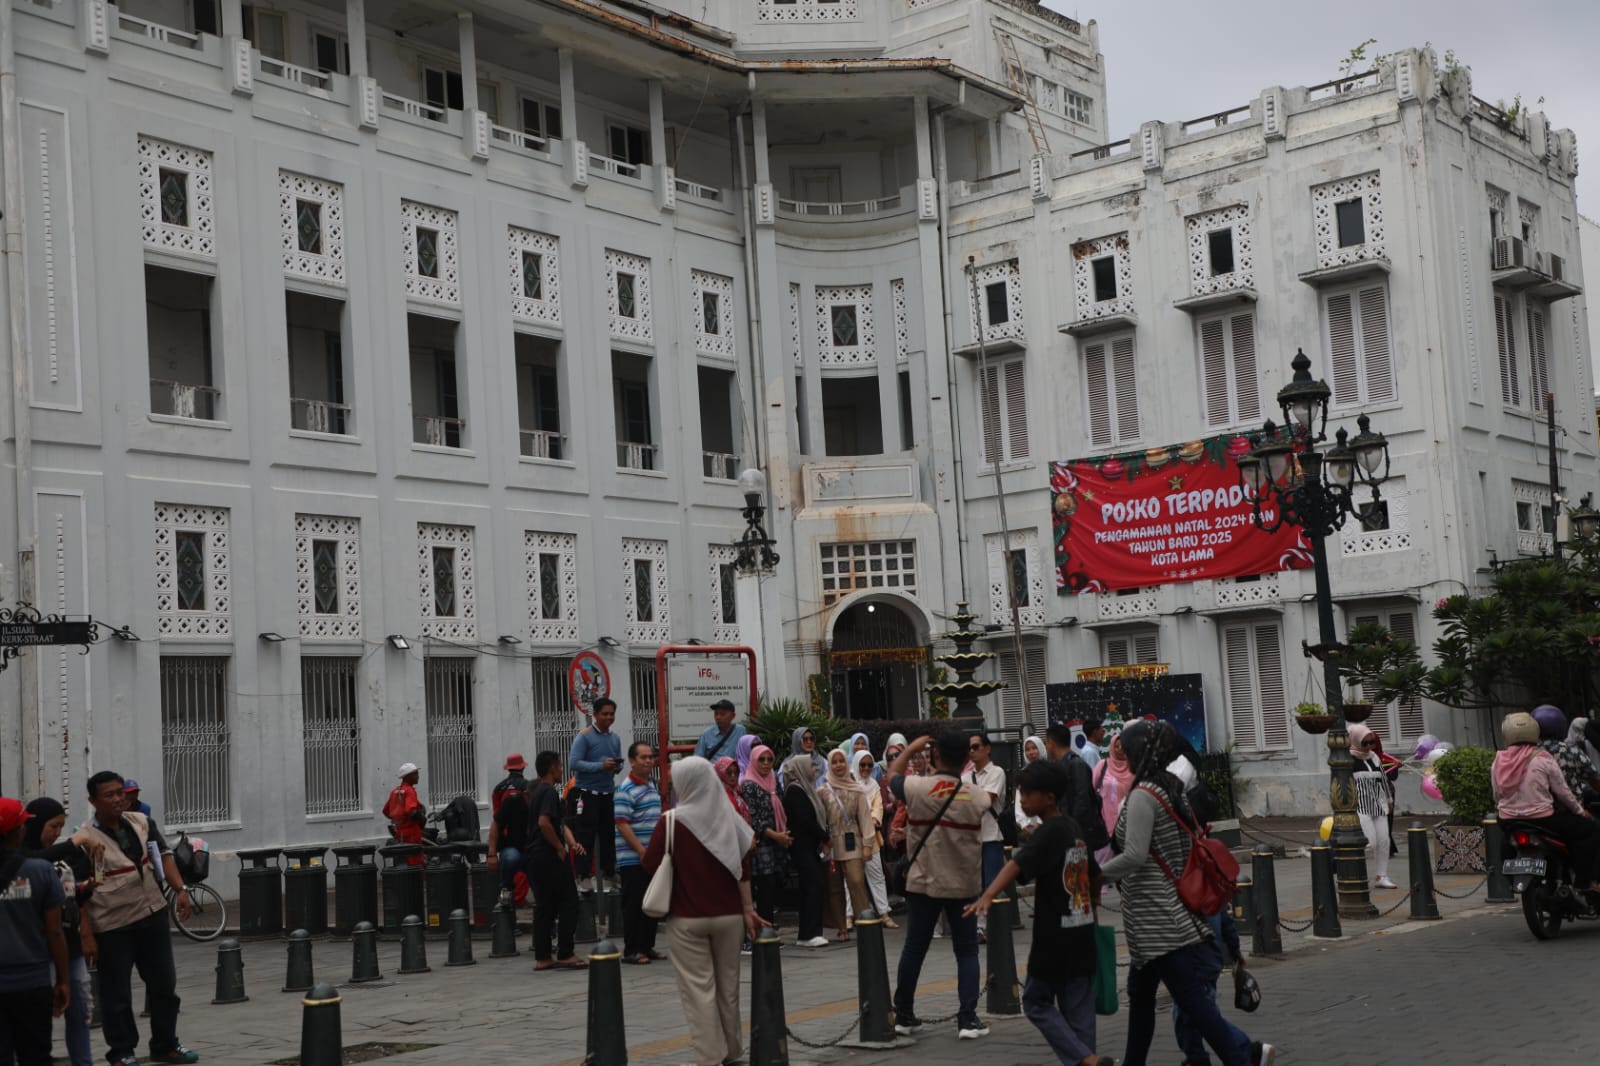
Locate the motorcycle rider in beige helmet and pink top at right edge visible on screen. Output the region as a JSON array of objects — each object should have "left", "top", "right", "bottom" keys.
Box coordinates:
[{"left": 1490, "top": 711, "right": 1600, "bottom": 892}]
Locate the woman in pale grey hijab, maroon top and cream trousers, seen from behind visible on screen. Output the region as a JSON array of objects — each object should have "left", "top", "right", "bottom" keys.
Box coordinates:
[{"left": 640, "top": 755, "right": 765, "bottom": 1066}]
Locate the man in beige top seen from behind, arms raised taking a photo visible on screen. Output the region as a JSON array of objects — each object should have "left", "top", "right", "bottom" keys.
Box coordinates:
[{"left": 886, "top": 731, "right": 989, "bottom": 1040}]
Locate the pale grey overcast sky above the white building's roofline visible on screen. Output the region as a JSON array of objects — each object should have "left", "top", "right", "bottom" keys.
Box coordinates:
[{"left": 1045, "top": 0, "right": 1600, "bottom": 219}]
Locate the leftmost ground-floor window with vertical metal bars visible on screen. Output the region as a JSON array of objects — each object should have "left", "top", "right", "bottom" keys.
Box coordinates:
[{"left": 160, "top": 655, "right": 234, "bottom": 828}]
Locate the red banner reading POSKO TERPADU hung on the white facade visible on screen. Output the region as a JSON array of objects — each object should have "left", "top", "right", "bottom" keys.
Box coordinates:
[{"left": 1050, "top": 435, "right": 1310, "bottom": 594}]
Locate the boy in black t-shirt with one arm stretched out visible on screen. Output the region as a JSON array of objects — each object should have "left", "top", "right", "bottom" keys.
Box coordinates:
[{"left": 966, "top": 759, "right": 1115, "bottom": 1066}]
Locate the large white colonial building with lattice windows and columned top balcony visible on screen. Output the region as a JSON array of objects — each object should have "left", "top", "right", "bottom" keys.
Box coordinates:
[{"left": 0, "top": 0, "right": 1600, "bottom": 870}]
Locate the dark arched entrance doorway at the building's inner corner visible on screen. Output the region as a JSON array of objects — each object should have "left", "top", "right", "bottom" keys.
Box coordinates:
[{"left": 829, "top": 597, "right": 928, "bottom": 719}]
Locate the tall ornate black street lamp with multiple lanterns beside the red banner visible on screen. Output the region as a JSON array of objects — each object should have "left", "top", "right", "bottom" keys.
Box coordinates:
[{"left": 1238, "top": 352, "right": 1389, "bottom": 917}]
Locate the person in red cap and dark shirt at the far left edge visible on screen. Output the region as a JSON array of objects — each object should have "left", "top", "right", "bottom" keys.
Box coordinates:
[{"left": 0, "top": 799, "right": 72, "bottom": 1066}]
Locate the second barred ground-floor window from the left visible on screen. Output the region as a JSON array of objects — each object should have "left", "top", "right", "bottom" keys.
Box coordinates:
[{"left": 301, "top": 655, "right": 365, "bottom": 815}]
